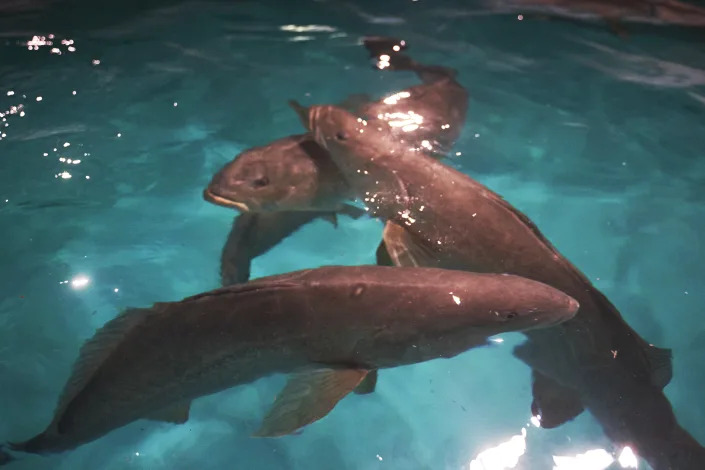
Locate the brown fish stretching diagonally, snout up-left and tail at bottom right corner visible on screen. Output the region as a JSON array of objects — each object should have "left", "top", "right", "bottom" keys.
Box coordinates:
[{"left": 292, "top": 102, "right": 705, "bottom": 470}]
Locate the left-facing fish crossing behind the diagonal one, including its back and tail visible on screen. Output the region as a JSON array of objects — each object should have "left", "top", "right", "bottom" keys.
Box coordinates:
[{"left": 203, "top": 36, "right": 469, "bottom": 286}]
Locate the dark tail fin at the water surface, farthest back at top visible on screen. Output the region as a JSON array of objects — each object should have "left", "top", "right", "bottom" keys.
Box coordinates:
[{"left": 362, "top": 36, "right": 457, "bottom": 84}]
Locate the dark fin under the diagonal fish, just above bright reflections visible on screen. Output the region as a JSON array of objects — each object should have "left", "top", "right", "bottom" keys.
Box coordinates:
[{"left": 531, "top": 370, "right": 584, "bottom": 429}]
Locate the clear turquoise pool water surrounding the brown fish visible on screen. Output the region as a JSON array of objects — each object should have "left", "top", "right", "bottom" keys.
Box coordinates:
[{"left": 0, "top": 0, "right": 705, "bottom": 470}]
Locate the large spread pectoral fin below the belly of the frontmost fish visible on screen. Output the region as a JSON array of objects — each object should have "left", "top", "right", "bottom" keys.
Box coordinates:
[{"left": 252, "top": 369, "right": 368, "bottom": 437}]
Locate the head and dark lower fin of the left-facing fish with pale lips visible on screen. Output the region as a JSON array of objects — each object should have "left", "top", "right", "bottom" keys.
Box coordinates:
[{"left": 204, "top": 134, "right": 366, "bottom": 286}]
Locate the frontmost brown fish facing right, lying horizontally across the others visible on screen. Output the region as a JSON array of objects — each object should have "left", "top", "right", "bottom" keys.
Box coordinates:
[{"left": 5, "top": 265, "right": 579, "bottom": 460}]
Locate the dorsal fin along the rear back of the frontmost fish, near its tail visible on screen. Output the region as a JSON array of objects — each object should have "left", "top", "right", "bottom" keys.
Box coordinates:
[{"left": 52, "top": 303, "right": 161, "bottom": 425}]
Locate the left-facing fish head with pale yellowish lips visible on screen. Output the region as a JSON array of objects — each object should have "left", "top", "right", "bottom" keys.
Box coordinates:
[{"left": 203, "top": 136, "right": 323, "bottom": 212}]
